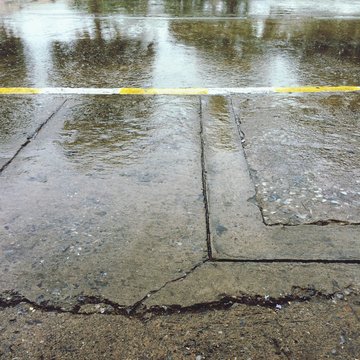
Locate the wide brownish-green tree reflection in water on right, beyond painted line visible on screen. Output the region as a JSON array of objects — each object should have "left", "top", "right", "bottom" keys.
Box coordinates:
[{"left": 170, "top": 19, "right": 360, "bottom": 86}]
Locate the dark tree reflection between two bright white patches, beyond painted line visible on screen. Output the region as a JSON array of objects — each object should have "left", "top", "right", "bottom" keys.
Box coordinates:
[{"left": 51, "top": 19, "right": 155, "bottom": 87}]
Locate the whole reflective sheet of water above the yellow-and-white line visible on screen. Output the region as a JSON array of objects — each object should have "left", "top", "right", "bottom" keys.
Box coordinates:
[{"left": 0, "top": 0, "right": 360, "bottom": 87}]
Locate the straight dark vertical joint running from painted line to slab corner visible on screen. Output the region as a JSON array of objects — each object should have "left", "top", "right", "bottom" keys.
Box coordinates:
[{"left": 199, "top": 96, "right": 213, "bottom": 260}]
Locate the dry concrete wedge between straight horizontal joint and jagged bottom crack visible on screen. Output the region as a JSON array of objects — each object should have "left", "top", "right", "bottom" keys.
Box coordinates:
[{"left": 144, "top": 262, "right": 360, "bottom": 308}]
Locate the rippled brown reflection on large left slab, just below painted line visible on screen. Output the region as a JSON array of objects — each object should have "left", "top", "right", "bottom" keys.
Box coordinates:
[{"left": 61, "top": 97, "right": 153, "bottom": 173}]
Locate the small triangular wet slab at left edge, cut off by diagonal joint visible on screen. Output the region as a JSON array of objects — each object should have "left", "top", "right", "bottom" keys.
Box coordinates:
[{"left": 0, "top": 95, "right": 64, "bottom": 169}]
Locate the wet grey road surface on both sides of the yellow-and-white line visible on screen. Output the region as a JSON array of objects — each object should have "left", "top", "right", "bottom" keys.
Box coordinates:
[{"left": 0, "top": 0, "right": 360, "bottom": 308}]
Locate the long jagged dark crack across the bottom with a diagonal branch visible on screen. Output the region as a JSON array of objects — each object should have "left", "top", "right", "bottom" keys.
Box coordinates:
[{"left": 0, "top": 286, "right": 358, "bottom": 320}]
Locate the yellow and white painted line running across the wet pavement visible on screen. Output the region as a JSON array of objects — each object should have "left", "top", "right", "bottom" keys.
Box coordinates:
[{"left": 0, "top": 86, "right": 360, "bottom": 96}]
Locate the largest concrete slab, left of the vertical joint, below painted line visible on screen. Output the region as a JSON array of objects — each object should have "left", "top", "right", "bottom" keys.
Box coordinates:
[{"left": 0, "top": 97, "right": 207, "bottom": 308}]
